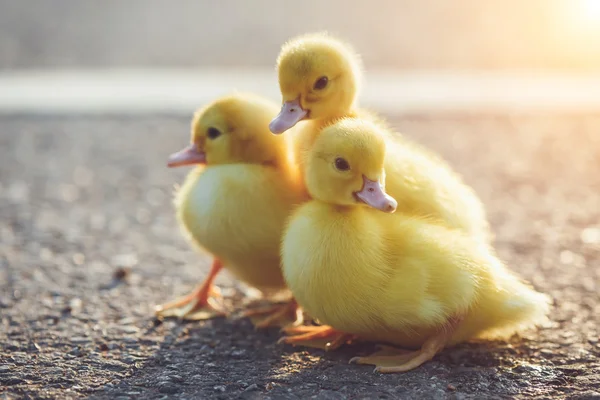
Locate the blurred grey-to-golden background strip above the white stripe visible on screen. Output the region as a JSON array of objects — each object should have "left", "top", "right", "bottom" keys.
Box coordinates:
[{"left": 0, "top": 0, "right": 600, "bottom": 72}]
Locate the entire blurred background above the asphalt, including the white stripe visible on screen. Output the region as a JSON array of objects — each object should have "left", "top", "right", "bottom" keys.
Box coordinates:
[{"left": 0, "top": 0, "right": 600, "bottom": 115}]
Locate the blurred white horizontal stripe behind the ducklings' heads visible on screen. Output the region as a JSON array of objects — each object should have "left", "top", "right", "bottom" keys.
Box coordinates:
[{"left": 0, "top": 69, "right": 600, "bottom": 114}]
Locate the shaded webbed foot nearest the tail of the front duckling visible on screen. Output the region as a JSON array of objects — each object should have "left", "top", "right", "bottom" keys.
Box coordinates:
[{"left": 350, "top": 318, "right": 462, "bottom": 374}]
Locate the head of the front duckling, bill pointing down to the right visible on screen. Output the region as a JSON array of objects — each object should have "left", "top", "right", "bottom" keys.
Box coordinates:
[{"left": 306, "top": 118, "right": 398, "bottom": 213}]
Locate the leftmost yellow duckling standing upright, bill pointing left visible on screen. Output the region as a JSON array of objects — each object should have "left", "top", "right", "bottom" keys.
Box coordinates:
[{"left": 157, "top": 94, "right": 306, "bottom": 327}]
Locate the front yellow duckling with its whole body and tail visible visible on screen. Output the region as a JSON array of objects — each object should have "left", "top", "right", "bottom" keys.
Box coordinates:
[{"left": 281, "top": 118, "right": 549, "bottom": 373}]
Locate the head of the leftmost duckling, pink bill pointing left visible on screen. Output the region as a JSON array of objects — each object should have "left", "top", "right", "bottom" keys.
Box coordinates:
[{"left": 168, "top": 94, "right": 287, "bottom": 167}]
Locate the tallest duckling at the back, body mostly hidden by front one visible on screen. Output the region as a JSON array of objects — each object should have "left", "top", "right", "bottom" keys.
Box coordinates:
[{"left": 269, "top": 33, "right": 491, "bottom": 242}]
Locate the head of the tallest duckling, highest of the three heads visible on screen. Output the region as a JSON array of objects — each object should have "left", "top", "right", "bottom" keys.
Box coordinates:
[{"left": 269, "top": 33, "right": 361, "bottom": 133}]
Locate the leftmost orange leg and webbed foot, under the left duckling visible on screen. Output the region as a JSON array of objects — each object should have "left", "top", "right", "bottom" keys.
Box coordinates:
[{"left": 156, "top": 258, "right": 225, "bottom": 320}]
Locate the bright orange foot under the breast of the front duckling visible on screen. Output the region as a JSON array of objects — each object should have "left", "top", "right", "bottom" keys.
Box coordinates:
[{"left": 277, "top": 325, "right": 355, "bottom": 350}]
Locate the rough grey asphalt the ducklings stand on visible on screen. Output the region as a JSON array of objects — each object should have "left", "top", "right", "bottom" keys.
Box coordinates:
[{"left": 0, "top": 115, "right": 600, "bottom": 399}]
